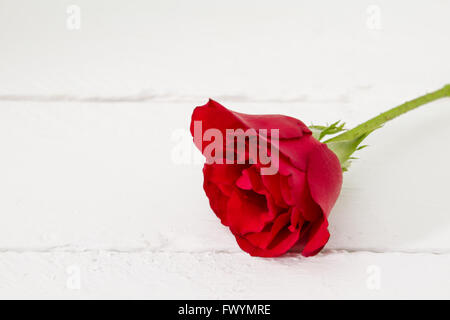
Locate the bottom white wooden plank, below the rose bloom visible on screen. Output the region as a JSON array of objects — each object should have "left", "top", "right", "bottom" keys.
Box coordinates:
[{"left": 0, "top": 252, "right": 450, "bottom": 299}]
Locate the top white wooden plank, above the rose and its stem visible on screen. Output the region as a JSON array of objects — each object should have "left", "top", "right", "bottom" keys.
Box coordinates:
[{"left": 0, "top": 0, "right": 450, "bottom": 101}]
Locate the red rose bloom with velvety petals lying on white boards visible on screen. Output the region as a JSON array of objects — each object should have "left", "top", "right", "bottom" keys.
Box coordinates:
[{"left": 191, "top": 100, "right": 342, "bottom": 257}]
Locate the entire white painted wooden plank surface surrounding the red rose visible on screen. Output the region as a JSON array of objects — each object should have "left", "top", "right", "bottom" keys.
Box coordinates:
[{"left": 0, "top": 0, "right": 450, "bottom": 299}]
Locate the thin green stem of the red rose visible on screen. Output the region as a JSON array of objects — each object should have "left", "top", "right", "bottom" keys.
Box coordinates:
[{"left": 325, "top": 84, "right": 450, "bottom": 143}]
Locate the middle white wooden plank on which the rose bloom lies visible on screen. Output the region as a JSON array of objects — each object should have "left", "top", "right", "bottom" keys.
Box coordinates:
[{"left": 0, "top": 101, "right": 450, "bottom": 252}]
